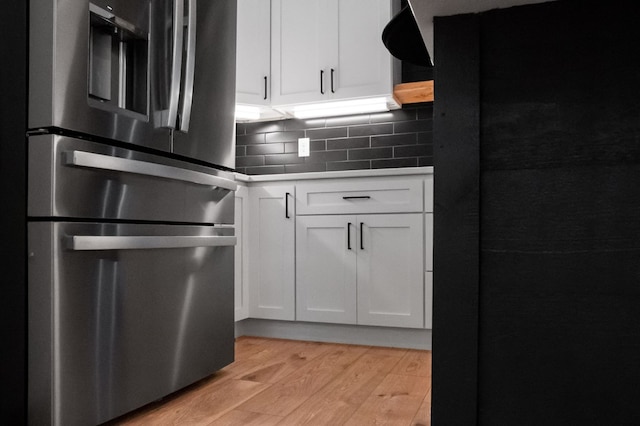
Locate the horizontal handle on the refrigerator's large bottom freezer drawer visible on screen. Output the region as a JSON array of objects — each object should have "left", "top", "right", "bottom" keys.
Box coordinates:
[{"left": 66, "top": 235, "right": 236, "bottom": 251}]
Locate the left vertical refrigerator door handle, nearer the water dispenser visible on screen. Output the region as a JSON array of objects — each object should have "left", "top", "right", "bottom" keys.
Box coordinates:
[{"left": 162, "top": 0, "right": 184, "bottom": 129}]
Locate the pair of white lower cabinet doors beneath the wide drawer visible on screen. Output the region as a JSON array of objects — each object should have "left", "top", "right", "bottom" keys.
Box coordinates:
[{"left": 296, "top": 213, "right": 424, "bottom": 328}]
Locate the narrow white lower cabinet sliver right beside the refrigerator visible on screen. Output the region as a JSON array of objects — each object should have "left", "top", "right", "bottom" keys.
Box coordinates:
[{"left": 234, "top": 186, "right": 250, "bottom": 321}]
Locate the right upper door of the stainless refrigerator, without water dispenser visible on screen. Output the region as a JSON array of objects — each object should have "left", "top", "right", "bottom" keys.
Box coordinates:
[{"left": 173, "top": 0, "right": 237, "bottom": 168}]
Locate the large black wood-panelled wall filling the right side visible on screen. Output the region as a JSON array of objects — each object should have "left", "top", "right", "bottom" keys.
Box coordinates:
[{"left": 433, "top": 0, "right": 640, "bottom": 425}]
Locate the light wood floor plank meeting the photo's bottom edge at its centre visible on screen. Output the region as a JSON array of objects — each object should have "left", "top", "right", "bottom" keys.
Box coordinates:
[{"left": 280, "top": 352, "right": 401, "bottom": 426}]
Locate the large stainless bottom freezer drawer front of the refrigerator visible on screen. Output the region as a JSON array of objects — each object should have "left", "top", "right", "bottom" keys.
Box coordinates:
[{"left": 28, "top": 222, "right": 234, "bottom": 426}]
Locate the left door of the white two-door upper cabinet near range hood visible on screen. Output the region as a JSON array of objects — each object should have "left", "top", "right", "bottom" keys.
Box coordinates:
[{"left": 272, "top": 0, "right": 332, "bottom": 105}]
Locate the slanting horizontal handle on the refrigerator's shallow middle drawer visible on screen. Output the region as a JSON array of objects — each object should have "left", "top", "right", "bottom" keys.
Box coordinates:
[{"left": 64, "top": 151, "right": 238, "bottom": 191}]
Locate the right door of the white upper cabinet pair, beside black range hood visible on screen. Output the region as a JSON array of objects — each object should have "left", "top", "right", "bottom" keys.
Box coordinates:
[{"left": 327, "top": 0, "right": 393, "bottom": 99}]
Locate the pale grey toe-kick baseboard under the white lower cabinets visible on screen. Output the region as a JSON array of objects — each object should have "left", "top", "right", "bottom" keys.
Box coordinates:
[{"left": 236, "top": 318, "right": 431, "bottom": 350}]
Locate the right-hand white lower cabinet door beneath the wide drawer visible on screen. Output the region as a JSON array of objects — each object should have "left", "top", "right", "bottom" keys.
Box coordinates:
[{"left": 357, "top": 213, "right": 424, "bottom": 328}]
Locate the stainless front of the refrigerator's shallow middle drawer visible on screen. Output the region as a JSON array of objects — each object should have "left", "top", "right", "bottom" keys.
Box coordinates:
[{"left": 28, "top": 135, "right": 234, "bottom": 224}]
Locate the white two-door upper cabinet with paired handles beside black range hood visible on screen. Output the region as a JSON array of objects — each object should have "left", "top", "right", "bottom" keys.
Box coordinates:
[{"left": 271, "top": 0, "right": 393, "bottom": 106}]
